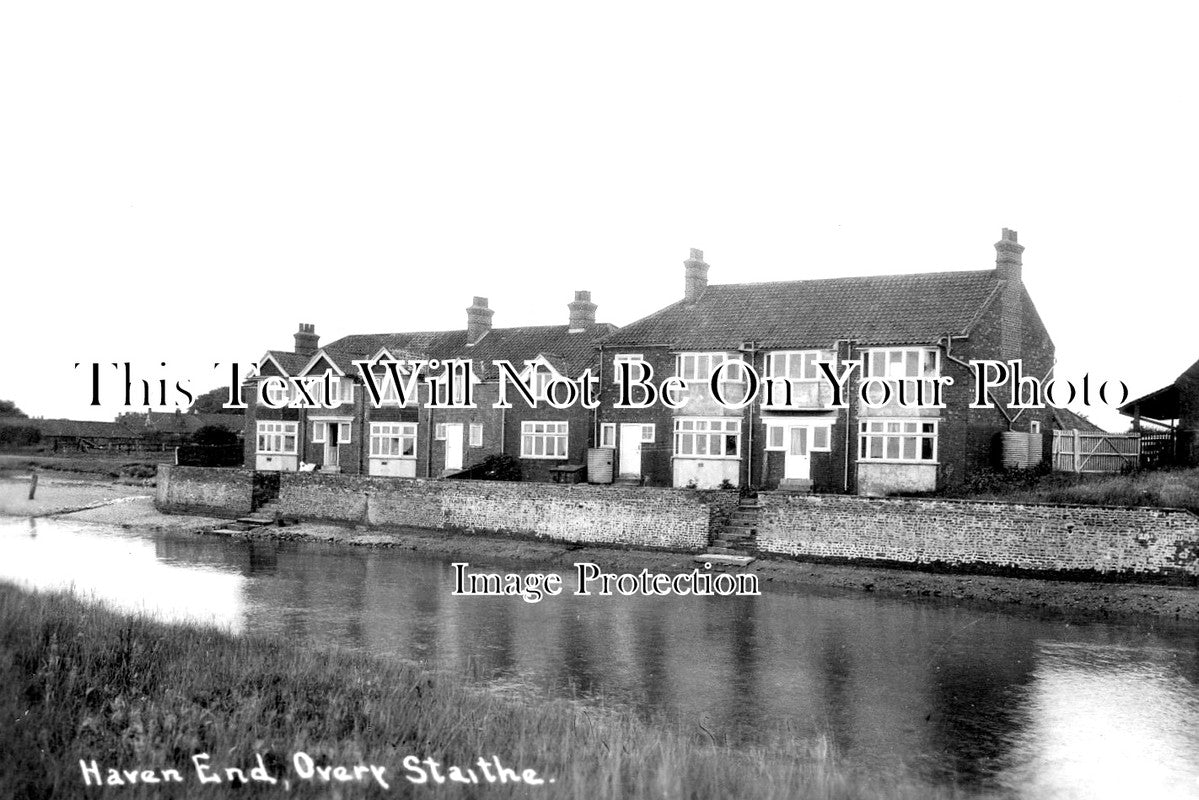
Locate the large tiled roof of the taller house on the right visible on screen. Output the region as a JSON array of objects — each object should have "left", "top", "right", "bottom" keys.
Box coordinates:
[{"left": 603, "top": 270, "right": 1000, "bottom": 349}]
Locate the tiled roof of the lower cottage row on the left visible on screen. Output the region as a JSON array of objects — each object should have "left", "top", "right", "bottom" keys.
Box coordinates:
[{"left": 325, "top": 323, "right": 616, "bottom": 380}]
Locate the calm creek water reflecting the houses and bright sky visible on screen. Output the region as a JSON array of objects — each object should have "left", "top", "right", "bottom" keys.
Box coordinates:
[{"left": 0, "top": 519, "right": 1199, "bottom": 798}]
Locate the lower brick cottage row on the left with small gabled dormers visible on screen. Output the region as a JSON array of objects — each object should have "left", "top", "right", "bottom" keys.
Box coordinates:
[{"left": 245, "top": 291, "right": 615, "bottom": 480}]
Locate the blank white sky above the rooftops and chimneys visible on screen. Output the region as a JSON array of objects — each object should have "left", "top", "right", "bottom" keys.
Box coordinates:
[{"left": 0, "top": 1, "right": 1199, "bottom": 429}]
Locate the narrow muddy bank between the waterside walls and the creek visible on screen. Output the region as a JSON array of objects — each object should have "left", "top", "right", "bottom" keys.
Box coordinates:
[{"left": 7, "top": 479, "right": 1199, "bottom": 620}]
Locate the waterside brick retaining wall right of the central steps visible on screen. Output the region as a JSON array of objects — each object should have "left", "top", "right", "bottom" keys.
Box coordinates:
[{"left": 758, "top": 493, "right": 1199, "bottom": 583}]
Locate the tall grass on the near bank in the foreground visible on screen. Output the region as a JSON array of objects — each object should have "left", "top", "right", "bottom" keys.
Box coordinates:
[{"left": 0, "top": 584, "right": 954, "bottom": 800}]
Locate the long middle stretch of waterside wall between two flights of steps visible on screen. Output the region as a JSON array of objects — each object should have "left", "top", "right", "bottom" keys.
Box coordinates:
[{"left": 279, "top": 473, "right": 712, "bottom": 551}]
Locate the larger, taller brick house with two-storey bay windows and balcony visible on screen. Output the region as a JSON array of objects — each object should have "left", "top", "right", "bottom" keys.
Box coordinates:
[{"left": 598, "top": 229, "right": 1054, "bottom": 494}]
